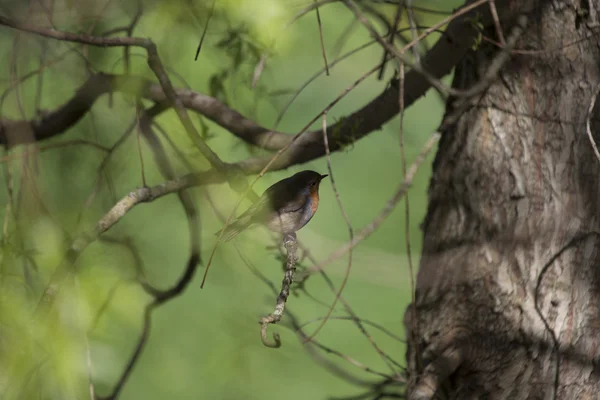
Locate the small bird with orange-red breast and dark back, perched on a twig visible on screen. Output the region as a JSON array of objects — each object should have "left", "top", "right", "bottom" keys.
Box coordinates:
[{"left": 216, "top": 170, "right": 328, "bottom": 242}]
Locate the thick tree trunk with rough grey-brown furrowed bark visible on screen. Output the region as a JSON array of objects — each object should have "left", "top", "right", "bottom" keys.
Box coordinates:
[{"left": 405, "top": 0, "right": 600, "bottom": 400}]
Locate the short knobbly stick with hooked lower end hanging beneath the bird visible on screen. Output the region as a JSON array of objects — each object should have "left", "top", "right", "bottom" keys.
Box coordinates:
[{"left": 260, "top": 234, "right": 298, "bottom": 348}]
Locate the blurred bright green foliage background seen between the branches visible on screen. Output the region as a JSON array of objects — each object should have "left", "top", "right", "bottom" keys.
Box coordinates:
[{"left": 0, "top": 0, "right": 460, "bottom": 399}]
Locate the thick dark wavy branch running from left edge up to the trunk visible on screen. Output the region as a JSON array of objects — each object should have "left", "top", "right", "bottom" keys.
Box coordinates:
[{"left": 0, "top": 1, "right": 508, "bottom": 161}]
